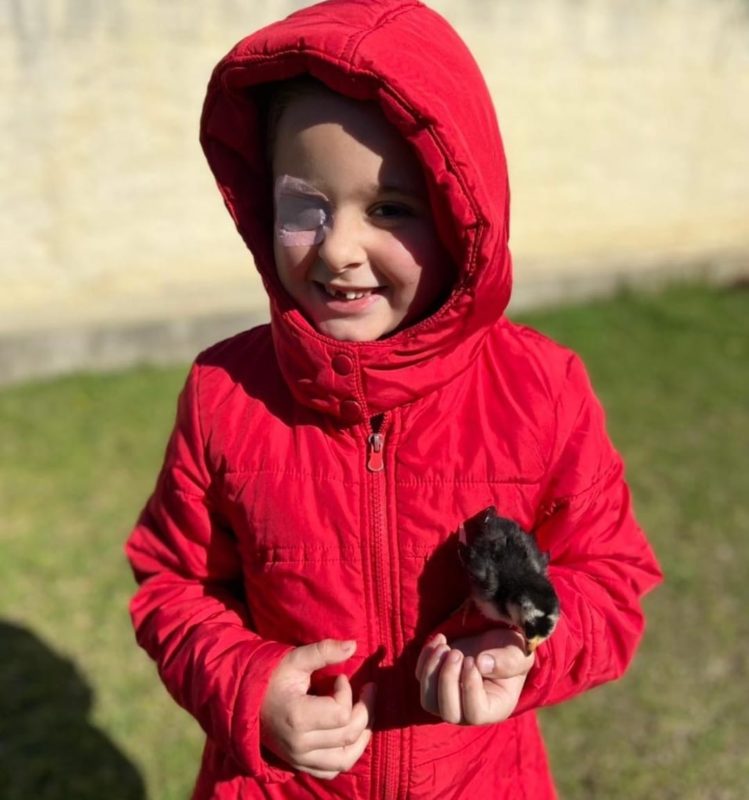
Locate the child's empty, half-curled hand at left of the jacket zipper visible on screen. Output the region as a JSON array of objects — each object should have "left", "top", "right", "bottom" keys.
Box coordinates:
[{"left": 260, "top": 639, "right": 375, "bottom": 780}]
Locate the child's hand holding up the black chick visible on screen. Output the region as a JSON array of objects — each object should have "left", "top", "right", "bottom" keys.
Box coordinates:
[{"left": 416, "top": 628, "right": 534, "bottom": 725}]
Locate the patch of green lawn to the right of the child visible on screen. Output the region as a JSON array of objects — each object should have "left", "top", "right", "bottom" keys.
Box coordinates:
[{"left": 520, "top": 287, "right": 749, "bottom": 800}]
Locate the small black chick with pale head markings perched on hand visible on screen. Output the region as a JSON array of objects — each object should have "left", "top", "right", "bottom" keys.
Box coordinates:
[{"left": 458, "top": 506, "right": 559, "bottom": 652}]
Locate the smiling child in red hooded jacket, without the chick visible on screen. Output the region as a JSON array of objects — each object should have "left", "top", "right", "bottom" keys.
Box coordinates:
[{"left": 127, "top": 0, "right": 660, "bottom": 800}]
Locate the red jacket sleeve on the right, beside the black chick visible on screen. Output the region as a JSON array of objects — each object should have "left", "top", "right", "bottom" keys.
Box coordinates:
[{"left": 515, "top": 356, "right": 662, "bottom": 714}]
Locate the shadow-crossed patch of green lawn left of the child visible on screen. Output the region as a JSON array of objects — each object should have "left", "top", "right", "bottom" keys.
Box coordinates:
[{"left": 0, "top": 368, "right": 201, "bottom": 800}]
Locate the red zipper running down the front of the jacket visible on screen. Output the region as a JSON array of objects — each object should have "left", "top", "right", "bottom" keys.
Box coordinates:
[{"left": 366, "top": 414, "right": 400, "bottom": 798}]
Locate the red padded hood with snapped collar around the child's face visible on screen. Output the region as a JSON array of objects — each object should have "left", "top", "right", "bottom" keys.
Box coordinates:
[{"left": 201, "top": 0, "right": 511, "bottom": 424}]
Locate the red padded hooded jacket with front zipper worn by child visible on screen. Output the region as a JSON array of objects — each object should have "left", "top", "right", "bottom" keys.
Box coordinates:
[{"left": 127, "top": 0, "right": 660, "bottom": 800}]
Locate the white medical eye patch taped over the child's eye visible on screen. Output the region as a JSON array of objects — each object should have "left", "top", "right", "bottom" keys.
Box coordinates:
[{"left": 274, "top": 175, "right": 332, "bottom": 247}]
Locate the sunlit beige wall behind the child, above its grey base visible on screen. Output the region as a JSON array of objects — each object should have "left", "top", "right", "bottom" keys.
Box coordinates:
[{"left": 0, "top": 0, "right": 749, "bottom": 332}]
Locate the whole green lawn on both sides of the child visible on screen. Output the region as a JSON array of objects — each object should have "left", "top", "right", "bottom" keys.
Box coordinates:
[{"left": 0, "top": 286, "right": 749, "bottom": 800}]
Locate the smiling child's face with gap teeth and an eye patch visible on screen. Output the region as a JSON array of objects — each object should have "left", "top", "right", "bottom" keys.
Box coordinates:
[{"left": 273, "top": 92, "right": 454, "bottom": 342}]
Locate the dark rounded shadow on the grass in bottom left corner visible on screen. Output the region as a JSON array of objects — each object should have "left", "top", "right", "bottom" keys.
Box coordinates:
[{"left": 0, "top": 622, "right": 145, "bottom": 800}]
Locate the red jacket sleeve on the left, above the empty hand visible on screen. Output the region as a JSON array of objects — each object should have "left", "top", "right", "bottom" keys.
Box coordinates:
[{"left": 126, "top": 366, "right": 292, "bottom": 782}]
